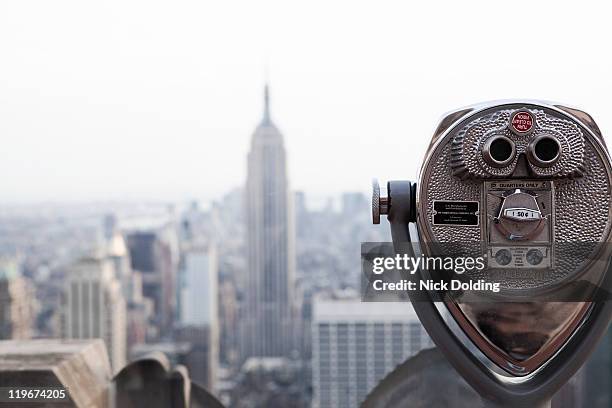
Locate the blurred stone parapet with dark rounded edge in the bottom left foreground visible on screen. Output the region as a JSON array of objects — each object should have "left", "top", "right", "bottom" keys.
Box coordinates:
[{"left": 0, "top": 339, "right": 223, "bottom": 408}]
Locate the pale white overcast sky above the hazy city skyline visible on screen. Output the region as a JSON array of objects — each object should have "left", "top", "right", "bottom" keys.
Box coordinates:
[{"left": 0, "top": 0, "right": 612, "bottom": 203}]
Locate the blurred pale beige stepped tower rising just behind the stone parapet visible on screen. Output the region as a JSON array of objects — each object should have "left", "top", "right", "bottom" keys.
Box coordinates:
[{"left": 62, "top": 257, "right": 127, "bottom": 372}]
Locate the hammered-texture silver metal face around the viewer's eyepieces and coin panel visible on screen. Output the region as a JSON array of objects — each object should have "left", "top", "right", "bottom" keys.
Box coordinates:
[{"left": 419, "top": 103, "right": 611, "bottom": 290}]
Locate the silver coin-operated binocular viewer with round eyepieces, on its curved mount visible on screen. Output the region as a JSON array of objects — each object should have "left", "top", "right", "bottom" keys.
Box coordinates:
[{"left": 372, "top": 101, "right": 612, "bottom": 407}]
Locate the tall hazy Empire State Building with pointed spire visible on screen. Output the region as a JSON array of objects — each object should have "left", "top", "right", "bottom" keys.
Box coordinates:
[{"left": 242, "top": 85, "right": 295, "bottom": 358}]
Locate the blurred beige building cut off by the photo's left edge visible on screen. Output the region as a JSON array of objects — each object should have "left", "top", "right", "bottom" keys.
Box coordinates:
[{"left": 0, "top": 259, "right": 36, "bottom": 340}]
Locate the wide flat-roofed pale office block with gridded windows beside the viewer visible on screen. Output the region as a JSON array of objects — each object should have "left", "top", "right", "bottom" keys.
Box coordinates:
[{"left": 312, "top": 297, "right": 433, "bottom": 408}]
